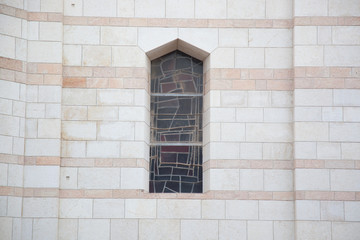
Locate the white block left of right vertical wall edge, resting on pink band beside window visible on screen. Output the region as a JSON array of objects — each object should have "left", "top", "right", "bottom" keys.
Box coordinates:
[{"left": 265, "top": 48, "right": 293, "bottom": 68}]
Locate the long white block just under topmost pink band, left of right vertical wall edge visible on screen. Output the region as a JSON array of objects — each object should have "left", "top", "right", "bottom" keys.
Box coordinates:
[{"left": 249, "top": 28, "right": 292, "bottom": 47}]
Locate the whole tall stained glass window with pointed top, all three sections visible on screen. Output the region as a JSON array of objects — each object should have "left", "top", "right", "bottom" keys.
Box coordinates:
[{"left": 150, "top": 51, "right": 203, "bottom": 193}]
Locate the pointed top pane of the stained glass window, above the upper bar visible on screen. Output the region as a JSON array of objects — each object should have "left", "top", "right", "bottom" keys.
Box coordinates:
[{"left": 151, "top": 51, "right": 203, "bottom": 93}]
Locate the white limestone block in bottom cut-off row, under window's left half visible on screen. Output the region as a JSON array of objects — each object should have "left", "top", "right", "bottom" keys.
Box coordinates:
[{"left": 139, "top": 219, "right": 180, "bottom": 240}]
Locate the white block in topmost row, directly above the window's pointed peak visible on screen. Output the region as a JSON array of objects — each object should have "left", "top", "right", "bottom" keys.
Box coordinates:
[{"left": 166, "top": 0, "right": 195, "bottom": 18}]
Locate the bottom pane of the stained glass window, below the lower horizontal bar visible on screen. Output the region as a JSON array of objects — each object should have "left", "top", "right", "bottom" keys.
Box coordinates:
[{"left": 150, "top": 146, "right": 202, "bottom": 193}]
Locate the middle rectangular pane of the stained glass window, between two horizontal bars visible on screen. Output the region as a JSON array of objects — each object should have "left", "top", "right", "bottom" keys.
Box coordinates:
[{"left": 151, "top": 96, "right": 202, "bottom": 143}]
